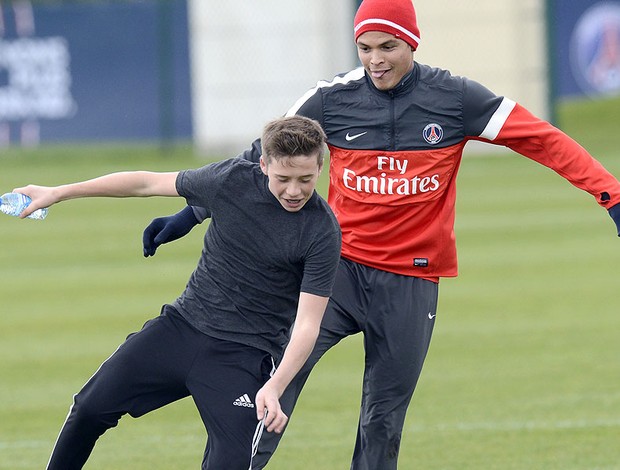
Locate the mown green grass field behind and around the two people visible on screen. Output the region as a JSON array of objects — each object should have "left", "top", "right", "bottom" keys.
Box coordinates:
[{"left": 0, "top": 99, "right": 620, "bottom": 470}]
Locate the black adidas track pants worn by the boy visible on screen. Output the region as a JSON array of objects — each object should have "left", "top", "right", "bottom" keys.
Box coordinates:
[{"left": 48, "top": 308, "right": 273, "bottom": 470}]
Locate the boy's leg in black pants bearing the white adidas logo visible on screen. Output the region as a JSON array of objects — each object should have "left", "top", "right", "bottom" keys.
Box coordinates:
[{"left": 187, "top": 336, "right": 273, "bottom": 470}]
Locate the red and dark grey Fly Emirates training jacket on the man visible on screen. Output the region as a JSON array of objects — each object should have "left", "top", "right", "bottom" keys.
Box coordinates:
[{"left": 241, "top": 63, "right": 620, "bottom": 280}]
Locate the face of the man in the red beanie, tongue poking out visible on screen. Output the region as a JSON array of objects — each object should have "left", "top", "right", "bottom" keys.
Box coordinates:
[{"left": 357, "top": 31, "right": 413, "bottom": 91}]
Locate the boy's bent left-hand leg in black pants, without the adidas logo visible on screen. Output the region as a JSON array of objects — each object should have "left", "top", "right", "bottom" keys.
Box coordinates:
[{"left": 47, "top": 308, "right": 191, "bottom": 470}]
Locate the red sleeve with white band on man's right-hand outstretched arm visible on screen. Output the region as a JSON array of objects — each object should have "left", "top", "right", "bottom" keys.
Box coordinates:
[{"left": 480, "top": 103, "right": 620, "bottom": 209}]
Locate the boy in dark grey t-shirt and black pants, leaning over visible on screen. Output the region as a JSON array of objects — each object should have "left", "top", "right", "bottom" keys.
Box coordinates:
[{"left": 15, "top": 116, "right": 340, "bottom": 470}]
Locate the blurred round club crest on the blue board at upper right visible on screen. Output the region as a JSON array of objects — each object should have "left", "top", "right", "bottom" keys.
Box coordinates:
[{"left": 570, "top": 1, "right": 620, "bottom": 95}]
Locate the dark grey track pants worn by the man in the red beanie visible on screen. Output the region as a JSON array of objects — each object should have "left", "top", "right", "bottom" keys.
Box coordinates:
[{"left": 252, "top": 259, "right": 438, "bottom": 470}]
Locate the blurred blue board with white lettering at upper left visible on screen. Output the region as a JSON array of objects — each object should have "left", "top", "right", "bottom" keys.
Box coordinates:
[{"left": 0, "top": 0, "right": 192, "bottom": 142}]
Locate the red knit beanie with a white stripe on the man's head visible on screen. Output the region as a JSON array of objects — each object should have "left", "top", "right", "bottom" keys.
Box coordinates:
[{"left": 353, "top": 0, "right": 420, "bottom": 50}]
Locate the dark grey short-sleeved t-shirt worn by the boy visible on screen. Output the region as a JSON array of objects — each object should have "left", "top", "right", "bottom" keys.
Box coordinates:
[{"left": 173, "top": 158, "right": 341, "bottom": 357}]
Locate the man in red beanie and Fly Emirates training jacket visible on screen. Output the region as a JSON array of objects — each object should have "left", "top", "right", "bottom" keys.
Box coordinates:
[{"left": 144, "top": 0, "right": 620, "bottom": 470}]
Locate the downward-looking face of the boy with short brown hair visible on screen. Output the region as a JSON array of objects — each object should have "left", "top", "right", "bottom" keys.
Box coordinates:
[{"left": 260, "top": 155, "right": 322, "bottom": 212}]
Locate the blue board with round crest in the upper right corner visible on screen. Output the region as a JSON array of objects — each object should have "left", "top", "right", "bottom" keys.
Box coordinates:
[{"left": 549, "top": 0, "right": 620, "bottom": 98}]
